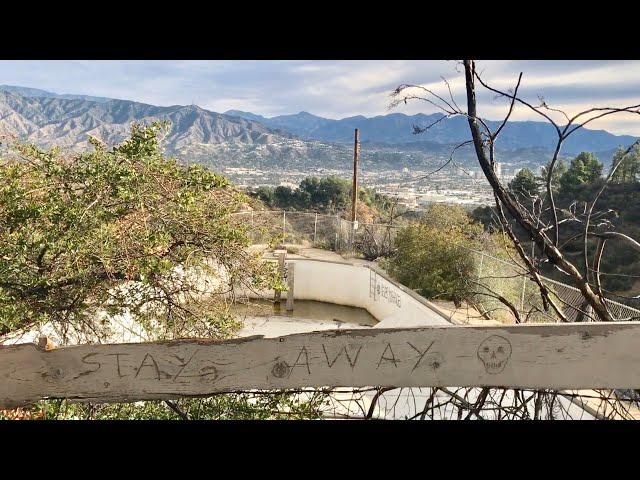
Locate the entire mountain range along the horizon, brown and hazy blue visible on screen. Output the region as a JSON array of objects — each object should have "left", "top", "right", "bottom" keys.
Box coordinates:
[{"left": 0, "top": 85, "right": 635, "bottom": 169}]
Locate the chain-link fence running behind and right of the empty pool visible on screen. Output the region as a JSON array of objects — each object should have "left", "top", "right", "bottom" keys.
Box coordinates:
[{"left": 233, "top": 210, "right": 640, "bottom": 322}]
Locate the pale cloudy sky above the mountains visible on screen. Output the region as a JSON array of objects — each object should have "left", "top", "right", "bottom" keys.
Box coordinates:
[{"left": 0, "top": 60, "right": 640, "bottom": 135}]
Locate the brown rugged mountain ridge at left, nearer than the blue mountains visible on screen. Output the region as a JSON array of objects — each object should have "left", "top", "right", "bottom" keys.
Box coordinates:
[{"left": 0, "top": 89, "right": 291, "bottom": 153}]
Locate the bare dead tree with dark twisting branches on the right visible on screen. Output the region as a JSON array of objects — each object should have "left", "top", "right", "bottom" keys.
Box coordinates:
[{"left": 391, "top": 60, "right": 640, "bottom": 321}]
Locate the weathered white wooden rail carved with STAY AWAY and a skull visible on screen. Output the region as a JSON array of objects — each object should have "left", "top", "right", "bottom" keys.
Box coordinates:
[{"left": 0, "top": 322, "right": 640, "bottom": 408}]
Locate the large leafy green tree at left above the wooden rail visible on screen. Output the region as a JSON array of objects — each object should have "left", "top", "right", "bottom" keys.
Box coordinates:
[{"left": 0, "top": 123, "right": 276, "bottom": 338}]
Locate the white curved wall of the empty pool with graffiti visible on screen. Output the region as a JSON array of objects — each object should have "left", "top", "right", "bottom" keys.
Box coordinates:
[{"left": 239, "top": 258, "right": 451, "bottom": 328}]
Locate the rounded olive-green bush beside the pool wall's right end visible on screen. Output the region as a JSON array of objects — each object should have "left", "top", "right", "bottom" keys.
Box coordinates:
[{"left": 385, "top": 204, "right": 483, "bottom": 305}]
